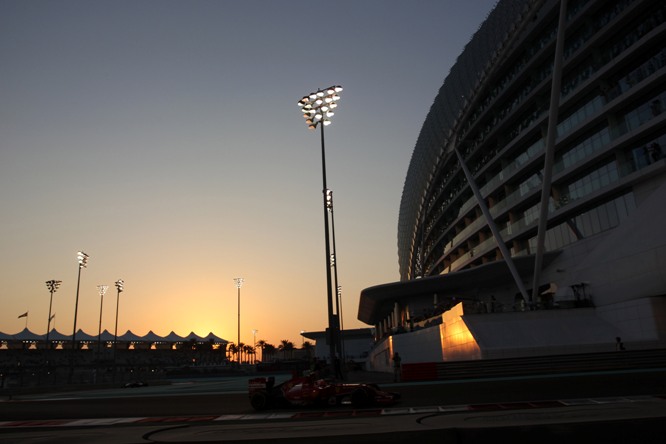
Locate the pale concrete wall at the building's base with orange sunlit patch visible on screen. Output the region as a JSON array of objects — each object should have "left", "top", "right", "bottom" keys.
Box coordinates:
[{"left": 366, "top": 298, "right": 666, "bottom": 372}]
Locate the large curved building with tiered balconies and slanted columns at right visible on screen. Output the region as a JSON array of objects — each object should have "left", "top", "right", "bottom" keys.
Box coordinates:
[{"left": 359, "top": 0, "right": 666, "bottom": 366}]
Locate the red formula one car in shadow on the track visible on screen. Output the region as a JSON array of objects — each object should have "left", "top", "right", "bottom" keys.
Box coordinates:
[{"left": 248, "top": 376, "right": 400, "bottom": 410}]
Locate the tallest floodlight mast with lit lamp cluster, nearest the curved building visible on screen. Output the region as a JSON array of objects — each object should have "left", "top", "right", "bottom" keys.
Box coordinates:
[{"left": 298, "top": 85, "right": 342, "bottom": 376}]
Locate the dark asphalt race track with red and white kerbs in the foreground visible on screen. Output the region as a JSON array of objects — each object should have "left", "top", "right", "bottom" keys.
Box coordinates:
[{"left": 0, "top": 369, "right": 666, "bottom": 444}]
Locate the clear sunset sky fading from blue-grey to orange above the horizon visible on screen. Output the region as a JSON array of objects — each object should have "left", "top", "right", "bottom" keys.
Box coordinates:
[{"left": 0, "top": 0, "right": 495, "bottom": 345}]
